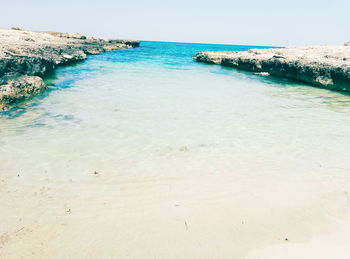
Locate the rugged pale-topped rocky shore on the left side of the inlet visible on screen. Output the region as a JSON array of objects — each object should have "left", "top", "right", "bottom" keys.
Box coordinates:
[{"left": 0, "top": 29, "right": 140, "bottom": 111}]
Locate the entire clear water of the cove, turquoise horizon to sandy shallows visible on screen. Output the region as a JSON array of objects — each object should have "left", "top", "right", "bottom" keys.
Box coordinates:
[{"left": 0, "top": 42, "right": 350, "bottom": 258}]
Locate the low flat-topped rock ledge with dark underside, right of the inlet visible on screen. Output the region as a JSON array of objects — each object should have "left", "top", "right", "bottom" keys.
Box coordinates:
[{"left": 194, "top": 46, "right": 350, "bottom": 91}]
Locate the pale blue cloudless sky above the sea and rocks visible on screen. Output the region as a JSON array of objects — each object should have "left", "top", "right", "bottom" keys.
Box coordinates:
[{"left": 0, "top": 0, "right": 350, "bottom": 46}]
